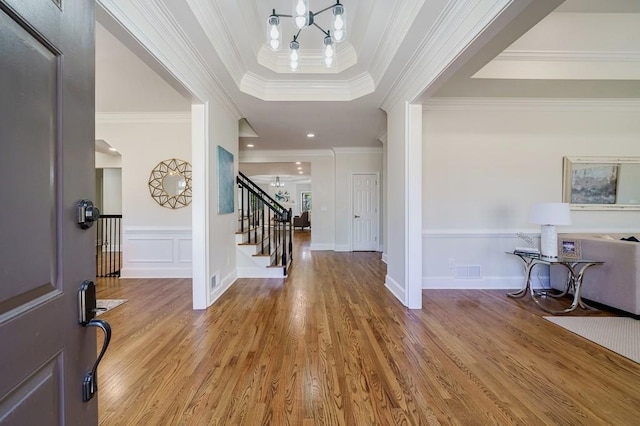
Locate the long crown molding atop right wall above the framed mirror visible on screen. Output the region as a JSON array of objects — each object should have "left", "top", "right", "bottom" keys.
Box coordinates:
[{"left": 422, "top": 98, "right": 640, "bottom": 112}]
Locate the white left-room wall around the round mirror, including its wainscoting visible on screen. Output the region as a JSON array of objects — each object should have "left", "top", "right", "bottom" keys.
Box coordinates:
[{"left": 96, "top": 113, "right": 192, "bottom": 278}]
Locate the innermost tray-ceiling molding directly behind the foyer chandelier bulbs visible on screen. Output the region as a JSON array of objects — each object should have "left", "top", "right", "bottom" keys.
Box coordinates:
[{"left": 258, "top": 42, "right": 358, "bottom": 75}]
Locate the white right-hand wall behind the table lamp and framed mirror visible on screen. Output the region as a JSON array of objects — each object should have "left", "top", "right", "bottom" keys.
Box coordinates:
[{"left": 423, "top": 100, "right": 640, "bottom": 288}]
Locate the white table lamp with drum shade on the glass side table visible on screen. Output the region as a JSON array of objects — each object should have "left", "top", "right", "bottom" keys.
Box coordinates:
[{"left": 529, "top": 203, "right": 571, "bottom": 259}]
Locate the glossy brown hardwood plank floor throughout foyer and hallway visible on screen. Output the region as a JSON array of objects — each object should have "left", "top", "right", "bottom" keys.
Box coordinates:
[{"left": 98, "top": 232, "right": 640, "bottom": 425}]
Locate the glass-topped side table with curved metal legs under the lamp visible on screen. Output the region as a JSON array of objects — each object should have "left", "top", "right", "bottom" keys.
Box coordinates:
[{"left": 506, "top": 251, "right": 604, "bottom": 315}]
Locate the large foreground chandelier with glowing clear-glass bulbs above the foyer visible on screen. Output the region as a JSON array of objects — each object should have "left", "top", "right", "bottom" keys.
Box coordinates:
[{"left": 267, "top": 0, "right": 347, "bottom": 71}]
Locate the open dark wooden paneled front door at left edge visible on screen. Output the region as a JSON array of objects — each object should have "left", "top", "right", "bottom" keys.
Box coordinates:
[{"left": 0, "top": 0, "right": 97, "bottom": 426}]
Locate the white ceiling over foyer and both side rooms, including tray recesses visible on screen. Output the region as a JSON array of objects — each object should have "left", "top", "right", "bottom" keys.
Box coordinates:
[{"left": 96, "top": 0, "right": 640, "bottom": 160}]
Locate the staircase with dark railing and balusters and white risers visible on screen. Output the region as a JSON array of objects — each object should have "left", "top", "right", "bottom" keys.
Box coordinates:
[{"left": 236, "top": 173, "right": 293, "bottom": 278}]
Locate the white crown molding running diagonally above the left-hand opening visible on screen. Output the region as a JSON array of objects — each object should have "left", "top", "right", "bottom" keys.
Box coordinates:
[{"left": 98, "top": 0, "right": 242, "bottom": 119}]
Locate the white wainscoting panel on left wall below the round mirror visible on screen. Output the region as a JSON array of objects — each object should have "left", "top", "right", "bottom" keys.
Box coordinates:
[{"left": 121, "top": 227, "right": 192, "bottom": 278}]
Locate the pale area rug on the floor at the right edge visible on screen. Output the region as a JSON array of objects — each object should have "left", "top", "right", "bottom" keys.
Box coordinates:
[{"left": 544, "top": 317, "right": 640, "bottom": 363}]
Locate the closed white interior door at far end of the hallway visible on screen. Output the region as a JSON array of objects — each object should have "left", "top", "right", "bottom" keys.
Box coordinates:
[{"left": 351, "top": 173, "right": 380, "bottom": 251}]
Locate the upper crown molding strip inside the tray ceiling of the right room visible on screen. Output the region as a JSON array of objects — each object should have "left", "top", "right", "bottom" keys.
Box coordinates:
[{"left": 493, "top": 50, "right": 640, "bottom": 62}]
